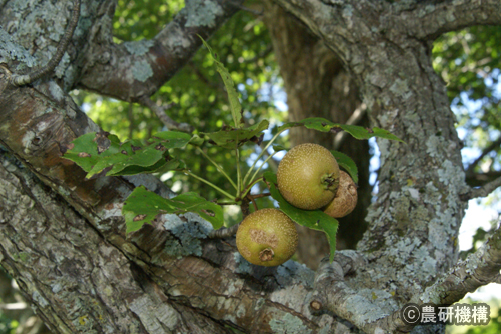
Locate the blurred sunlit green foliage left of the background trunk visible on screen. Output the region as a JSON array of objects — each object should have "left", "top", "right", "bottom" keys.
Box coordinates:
[{"left": 74, "top": 1, "right": 285, "bottom": 225}]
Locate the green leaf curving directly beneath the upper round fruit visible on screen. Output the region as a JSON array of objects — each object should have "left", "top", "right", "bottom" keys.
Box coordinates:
[{"left": 263, "top": 172, "right": 338, "bottom": 262}]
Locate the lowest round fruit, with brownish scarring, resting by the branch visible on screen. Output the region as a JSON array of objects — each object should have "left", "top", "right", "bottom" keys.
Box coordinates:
[{"left": 237, "top": 209, "right": 298, "bottom": 267}]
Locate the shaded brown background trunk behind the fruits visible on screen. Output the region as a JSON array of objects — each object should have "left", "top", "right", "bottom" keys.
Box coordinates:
[{"left": 263, "top": 2, "right": 372, "bottom": 269}]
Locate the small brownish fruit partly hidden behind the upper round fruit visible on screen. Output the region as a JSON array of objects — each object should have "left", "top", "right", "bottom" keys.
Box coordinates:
[{"left": 324, "top": 171, "right": 358, "bottom": 218}]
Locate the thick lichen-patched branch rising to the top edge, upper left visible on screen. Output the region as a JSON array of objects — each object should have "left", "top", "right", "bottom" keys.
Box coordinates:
[{"left": 79, "top": 0, "right": 243, "bottom": 101}]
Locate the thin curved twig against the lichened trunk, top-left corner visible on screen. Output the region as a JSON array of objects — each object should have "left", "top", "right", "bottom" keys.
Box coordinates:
[{"left": 11, "top": 0, "right": 80, "bottom": 86}]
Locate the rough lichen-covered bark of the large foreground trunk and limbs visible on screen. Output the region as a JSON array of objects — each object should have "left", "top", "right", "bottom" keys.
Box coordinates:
[{"left": 0, "top": 0, "right": 501, "bottom": 333}]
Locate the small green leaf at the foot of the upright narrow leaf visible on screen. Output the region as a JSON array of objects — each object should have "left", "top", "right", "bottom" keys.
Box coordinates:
[{"left": 200, "top": 119, "right": 270, "bottom": 149}]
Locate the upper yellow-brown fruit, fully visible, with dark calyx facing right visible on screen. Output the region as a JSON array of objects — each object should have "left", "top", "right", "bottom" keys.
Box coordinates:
[{"left": 277, "top": 144, "right": 339, "bottom": 210}]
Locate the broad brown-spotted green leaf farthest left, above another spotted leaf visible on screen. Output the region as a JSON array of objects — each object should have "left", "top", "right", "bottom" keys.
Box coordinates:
[{"left": 64, "top": 131, "right": 191, "bottom": 179}]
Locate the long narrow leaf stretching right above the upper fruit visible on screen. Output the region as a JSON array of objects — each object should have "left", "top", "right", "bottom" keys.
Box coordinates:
[{"left": 278, "top": 117, "right": 404, "bottom": 143}]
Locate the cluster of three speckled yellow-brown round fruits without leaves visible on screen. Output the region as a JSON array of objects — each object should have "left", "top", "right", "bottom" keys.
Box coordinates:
[{"left": 236, "top": 144, "right": 357, "bottom": 266}]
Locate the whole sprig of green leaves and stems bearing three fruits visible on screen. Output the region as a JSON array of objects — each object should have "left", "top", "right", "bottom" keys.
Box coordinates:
[{"left": 64, "top": 39, "right": 402, "bottom": 266}]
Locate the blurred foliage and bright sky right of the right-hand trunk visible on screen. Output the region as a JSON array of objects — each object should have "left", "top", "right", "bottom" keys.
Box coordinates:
[{"left": 433, "top": 26, "right": 501, "bottom": 256}]
